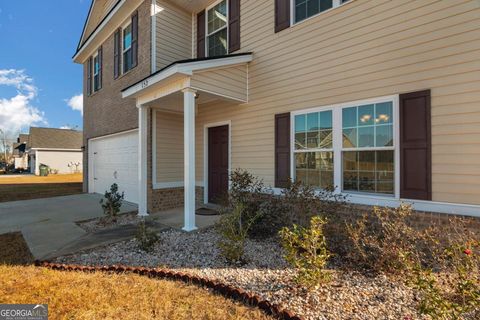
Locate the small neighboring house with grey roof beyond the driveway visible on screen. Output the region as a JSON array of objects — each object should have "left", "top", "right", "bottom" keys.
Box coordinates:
[{"left": 26, "top": 127, "right": 83, "bottom": 175}]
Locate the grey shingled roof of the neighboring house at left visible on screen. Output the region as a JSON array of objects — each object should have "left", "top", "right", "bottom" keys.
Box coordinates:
[{"left": 27, "top": 127, "right": 83, "bottom": 149}]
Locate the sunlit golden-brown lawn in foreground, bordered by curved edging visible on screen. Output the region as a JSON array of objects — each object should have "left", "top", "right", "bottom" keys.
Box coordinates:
[{"left": 0, "top": 266, "right": 272, "bottom": 320}]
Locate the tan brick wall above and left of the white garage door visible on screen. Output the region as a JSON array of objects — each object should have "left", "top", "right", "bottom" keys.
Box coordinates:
[{"left": 83, "top": 1, "right": 151, "bottom": 191}]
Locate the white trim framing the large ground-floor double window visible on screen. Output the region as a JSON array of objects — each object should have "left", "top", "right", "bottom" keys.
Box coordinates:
[{"left": 290, "top": 95, "right": 400, "bottom": 199}]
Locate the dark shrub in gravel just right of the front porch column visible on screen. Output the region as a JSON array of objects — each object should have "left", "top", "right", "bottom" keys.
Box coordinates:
[{"left": 216, "top": 203, "right": 259, "bottom": 263}]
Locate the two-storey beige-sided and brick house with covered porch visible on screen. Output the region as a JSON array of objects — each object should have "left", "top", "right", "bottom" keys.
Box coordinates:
[{"left": 73, "top": 0, "right": 480, "bottom": 230}]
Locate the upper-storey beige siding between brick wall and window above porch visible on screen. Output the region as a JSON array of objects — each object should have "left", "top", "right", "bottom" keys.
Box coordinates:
[{"left": 155, "top": 0, "right": 192, "bottom": 70}]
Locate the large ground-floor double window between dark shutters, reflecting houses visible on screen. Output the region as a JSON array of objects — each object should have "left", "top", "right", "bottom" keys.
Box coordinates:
[{"left": 292, "top": 98, "right": 398, "bottom": 195}]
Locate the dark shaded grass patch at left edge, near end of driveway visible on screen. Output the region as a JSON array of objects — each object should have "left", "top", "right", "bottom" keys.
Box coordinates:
[{"left": 0, "top": 232, "right": 34, "bottom": 265}]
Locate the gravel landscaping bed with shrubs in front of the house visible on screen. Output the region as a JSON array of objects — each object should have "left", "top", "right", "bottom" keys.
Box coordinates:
[{"left": 55, "top": 171, "right": 480, "bottom": 320}]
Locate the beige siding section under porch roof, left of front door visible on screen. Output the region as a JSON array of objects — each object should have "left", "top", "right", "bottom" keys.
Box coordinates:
[{"left": 155, "top": 111, "right": 183, "bottom": 183}]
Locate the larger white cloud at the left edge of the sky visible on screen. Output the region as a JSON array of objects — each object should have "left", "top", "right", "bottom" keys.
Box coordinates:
[{"left": 0, "top": 69, "right": 47, "bottom": 133}]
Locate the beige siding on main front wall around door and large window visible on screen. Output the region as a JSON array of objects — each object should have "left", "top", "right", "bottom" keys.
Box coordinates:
[{"left": 187, "top": 0, "right": 480, "bottom": 204}]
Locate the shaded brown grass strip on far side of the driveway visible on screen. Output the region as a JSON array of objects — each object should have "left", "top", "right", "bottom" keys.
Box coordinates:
[{"left": 0, "top": 182, "right": 83, "bottom": 202}]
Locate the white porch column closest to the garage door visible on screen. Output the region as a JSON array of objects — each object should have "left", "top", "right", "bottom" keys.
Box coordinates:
[{"left": 138, "top": 105, "right": 148, "bottom": 216}]
